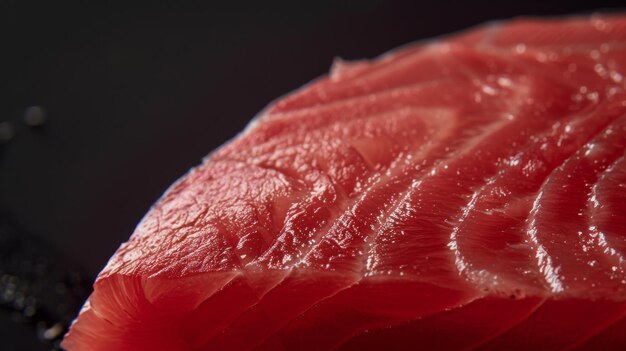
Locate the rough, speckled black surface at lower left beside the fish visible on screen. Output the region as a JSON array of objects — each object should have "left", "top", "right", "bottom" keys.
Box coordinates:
[{"left": 0, "top": 212, "right": 91, "bottom": 350}]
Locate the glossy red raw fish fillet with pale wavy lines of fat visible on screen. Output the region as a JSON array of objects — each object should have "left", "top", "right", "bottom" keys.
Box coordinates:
[{"left": 63, "top": 15, "right": 626, "bottom": 351}]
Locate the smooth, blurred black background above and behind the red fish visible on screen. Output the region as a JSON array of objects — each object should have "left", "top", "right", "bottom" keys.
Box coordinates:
[{"left": 0, "top": 0, "right": 620, "bottom": 351}]
